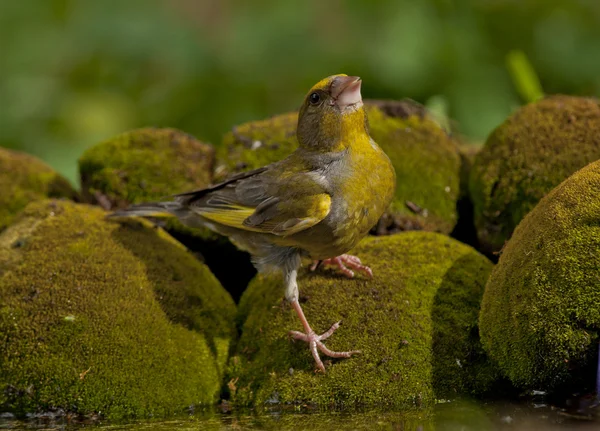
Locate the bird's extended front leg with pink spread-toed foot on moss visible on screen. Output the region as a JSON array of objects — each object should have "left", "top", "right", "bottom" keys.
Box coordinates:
[{"left": 284, "top": 263, "right": 360, "bottom": 373}]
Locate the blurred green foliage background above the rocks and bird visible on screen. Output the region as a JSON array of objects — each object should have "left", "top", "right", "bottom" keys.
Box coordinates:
[{"left": 0, "top": 0, "right": 600, "bottom": 181}]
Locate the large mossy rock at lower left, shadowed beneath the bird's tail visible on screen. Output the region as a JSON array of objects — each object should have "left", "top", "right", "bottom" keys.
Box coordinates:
[{"left": 0, "top": 201, "right": 235, "bottom": 418}]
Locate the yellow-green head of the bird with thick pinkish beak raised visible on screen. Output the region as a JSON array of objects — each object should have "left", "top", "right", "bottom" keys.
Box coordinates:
[{"left": 297, "top": 75, "right": 368, "bottom": 151}]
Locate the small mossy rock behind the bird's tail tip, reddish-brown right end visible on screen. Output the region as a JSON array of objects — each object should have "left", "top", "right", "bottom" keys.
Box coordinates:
[{"left": 79, "top": 128, "right": 214, "bottom": 209}]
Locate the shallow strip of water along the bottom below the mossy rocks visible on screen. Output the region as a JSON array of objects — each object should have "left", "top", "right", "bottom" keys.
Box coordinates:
[{"left": 0, "top": 396, "right": 600, "bottom": 431}]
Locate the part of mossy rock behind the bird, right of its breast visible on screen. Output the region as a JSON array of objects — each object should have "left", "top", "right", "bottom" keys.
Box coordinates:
[{"left": 367, "top": 100, "right": 461, "bottom": 234}]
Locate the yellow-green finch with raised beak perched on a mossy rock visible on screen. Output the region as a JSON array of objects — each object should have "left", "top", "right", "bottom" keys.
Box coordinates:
[{"left": 111, "top": 74, "right": 396, "bottom": 373}]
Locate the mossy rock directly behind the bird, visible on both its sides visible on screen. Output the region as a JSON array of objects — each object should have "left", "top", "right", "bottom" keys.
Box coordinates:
[{"left": 216, "top": 101, "right": 461, "bottom": 234}]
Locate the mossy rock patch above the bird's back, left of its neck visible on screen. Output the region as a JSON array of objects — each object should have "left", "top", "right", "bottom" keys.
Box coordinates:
[{"left": 215, "top": 112, "right": 298, "bottom": 180}]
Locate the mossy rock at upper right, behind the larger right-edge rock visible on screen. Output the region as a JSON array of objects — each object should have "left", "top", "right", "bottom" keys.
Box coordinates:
[{"left": 470, "top": 96, "right": 600, "bottom": 252}]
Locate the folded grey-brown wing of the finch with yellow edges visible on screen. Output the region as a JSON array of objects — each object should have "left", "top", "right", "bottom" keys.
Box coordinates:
[{"left": 177, "top": 169, "right": 331, "bottom": 236}]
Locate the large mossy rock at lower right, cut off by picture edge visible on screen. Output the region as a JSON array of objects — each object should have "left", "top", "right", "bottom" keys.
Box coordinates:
[{"left": 480, "top": 161, "right": 600, "bottom": 389}]
